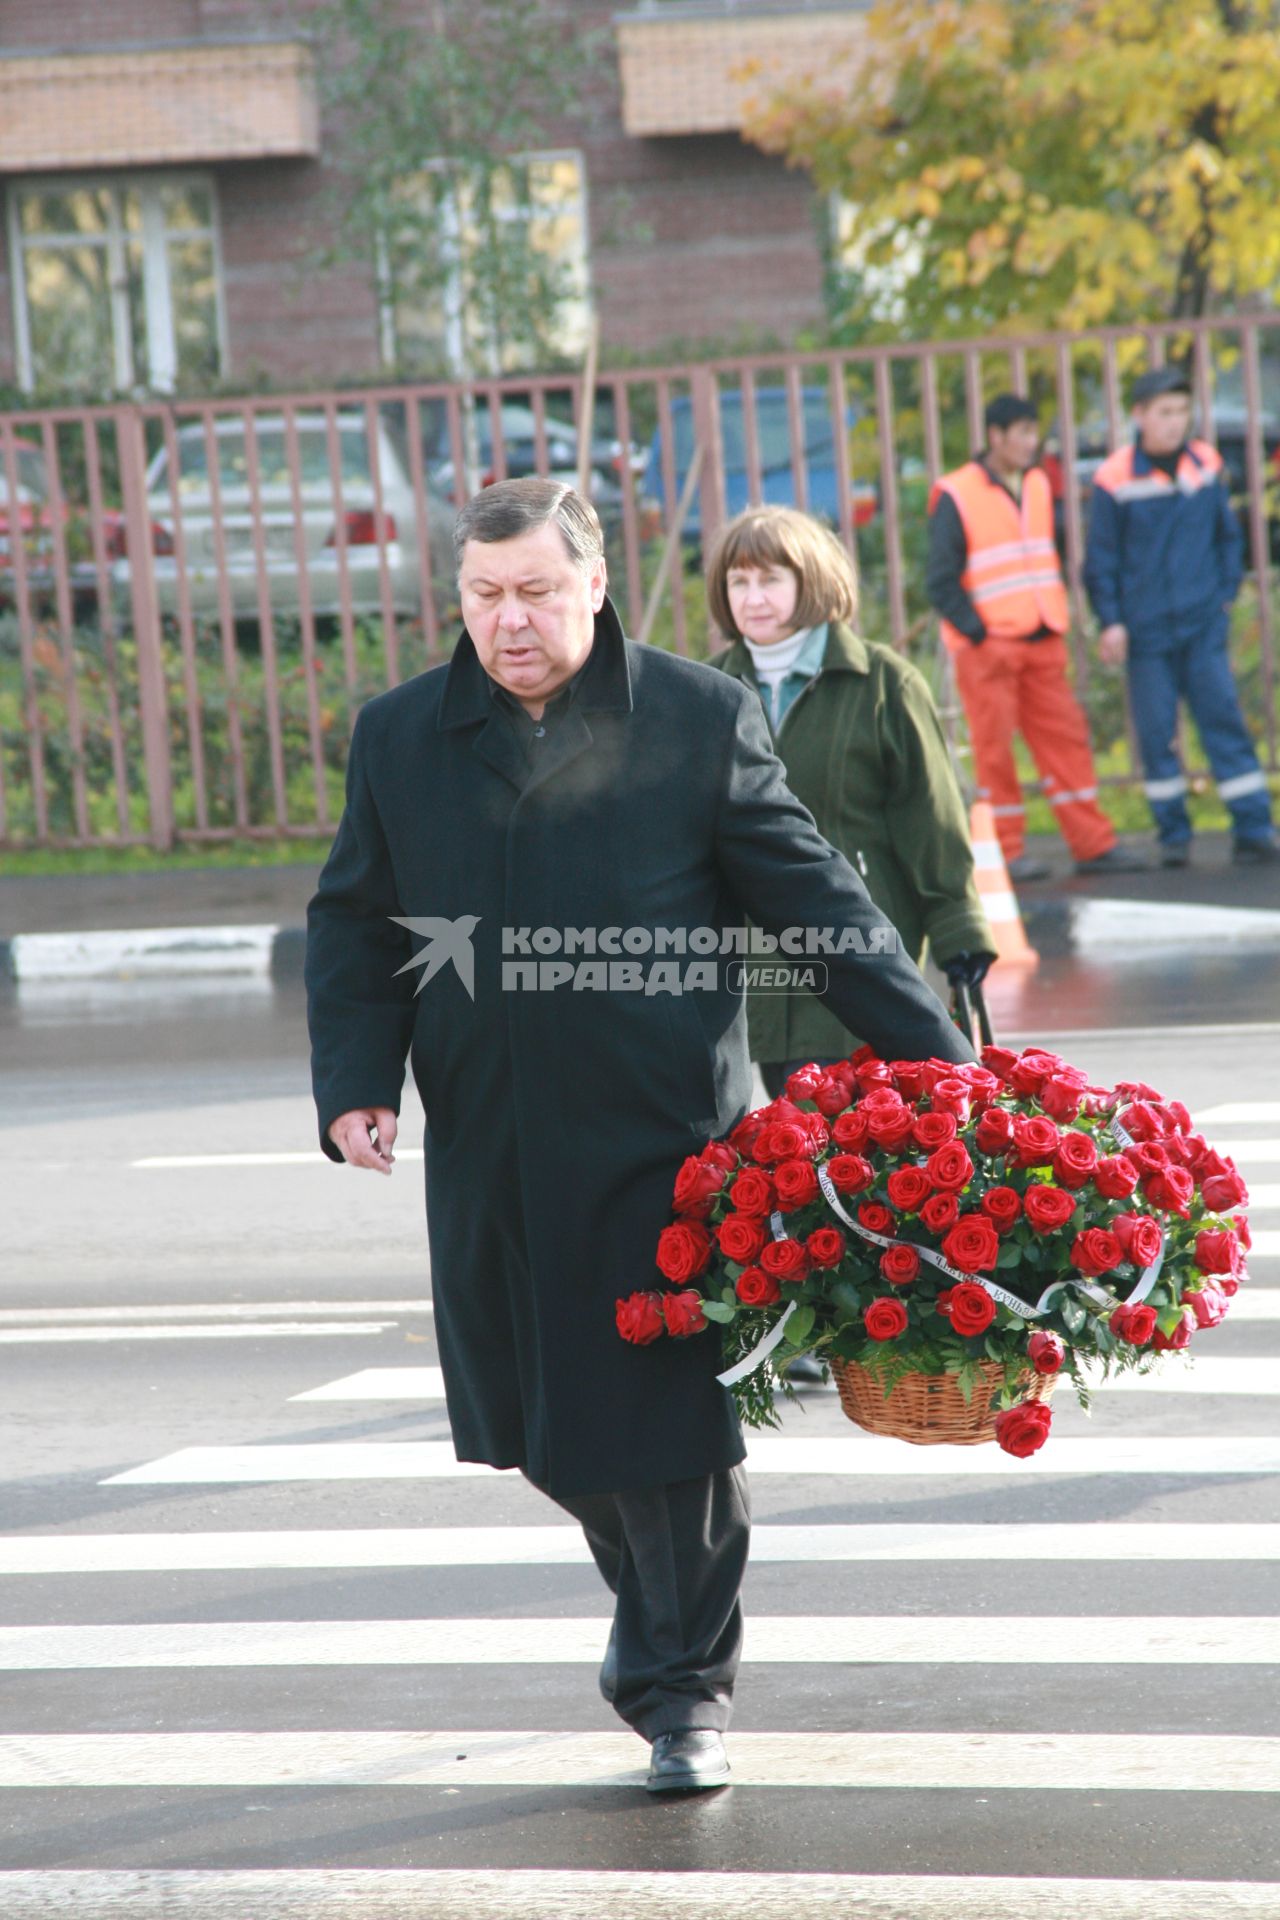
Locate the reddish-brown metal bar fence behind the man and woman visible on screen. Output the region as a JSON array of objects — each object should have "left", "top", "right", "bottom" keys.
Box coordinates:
[{"left": 0, "top": 317, "right": 1280, "bottom": 847}]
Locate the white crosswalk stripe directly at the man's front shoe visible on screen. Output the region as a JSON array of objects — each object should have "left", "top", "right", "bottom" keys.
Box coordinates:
[{"left": 0, "top": 1728, "right": 1280, "bottom": 1795}]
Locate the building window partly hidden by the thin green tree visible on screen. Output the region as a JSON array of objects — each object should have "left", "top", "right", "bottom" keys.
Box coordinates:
[{"left": 380, "top": 152, "right": 591, "bottom": 376}]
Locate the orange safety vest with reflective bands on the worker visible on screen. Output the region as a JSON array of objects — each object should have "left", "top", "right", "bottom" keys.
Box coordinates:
[{"left": 938, "top": 461, "right": 1071, "bottom": 649}]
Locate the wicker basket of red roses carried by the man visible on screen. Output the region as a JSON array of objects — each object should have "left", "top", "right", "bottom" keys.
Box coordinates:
[{"left": 616, "top": 1046, "right": 1249, "bottom": 1455}]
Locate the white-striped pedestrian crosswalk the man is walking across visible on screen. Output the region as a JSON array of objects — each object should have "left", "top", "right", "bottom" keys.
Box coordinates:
[{"left": 0, "top": 1108, "right": 1280, "bottom": 1920}]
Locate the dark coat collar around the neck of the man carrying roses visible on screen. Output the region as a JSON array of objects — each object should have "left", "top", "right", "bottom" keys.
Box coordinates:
[{"left": 436, "top": 599, "right": 635, "bottom": 799}]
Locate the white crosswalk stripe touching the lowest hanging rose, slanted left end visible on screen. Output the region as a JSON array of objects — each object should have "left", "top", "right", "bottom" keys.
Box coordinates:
[{"left": 100, "top": 1434, "right": 1280, "bottom": 1486}]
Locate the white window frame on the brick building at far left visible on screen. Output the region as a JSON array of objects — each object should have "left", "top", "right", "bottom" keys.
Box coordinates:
[{"left": 4, "top": 167, "right": 228, "bottom": 394}]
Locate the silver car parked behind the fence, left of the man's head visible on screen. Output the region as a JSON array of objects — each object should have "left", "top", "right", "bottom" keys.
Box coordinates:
[{"left": 113, "top": 411, "right": 453, "bottom": 620}]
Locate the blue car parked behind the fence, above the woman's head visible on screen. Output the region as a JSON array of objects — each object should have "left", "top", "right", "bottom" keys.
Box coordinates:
[{"left": 643, "top": 386, "right": 879, "bottom": 543}]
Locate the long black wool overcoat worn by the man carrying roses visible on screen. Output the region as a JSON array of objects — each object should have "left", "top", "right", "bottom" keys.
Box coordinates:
[{"left": 307, "top": 601, "right": 971, "bottom": 1494}]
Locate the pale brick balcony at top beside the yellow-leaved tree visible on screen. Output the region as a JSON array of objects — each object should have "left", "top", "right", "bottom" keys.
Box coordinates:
[{"left": 616, "top": 0, "right": 867, "bottom": 136}]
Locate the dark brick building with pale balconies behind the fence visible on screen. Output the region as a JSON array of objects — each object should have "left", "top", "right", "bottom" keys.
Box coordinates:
[{"left": 0, "top": 0, "right": 864, "bottom": 392}]
